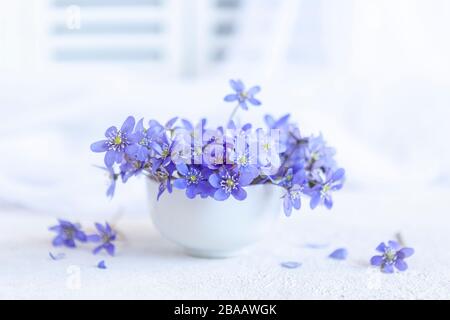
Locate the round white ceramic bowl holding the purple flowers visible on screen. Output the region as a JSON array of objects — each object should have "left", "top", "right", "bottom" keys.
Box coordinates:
[{"left": 148, "top": 180, "right": 282, "bottom": 258}]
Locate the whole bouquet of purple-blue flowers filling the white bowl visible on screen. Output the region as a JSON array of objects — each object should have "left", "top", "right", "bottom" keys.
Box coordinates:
[{"left": 91, "top": 80, "right": 345, "bottom": 216}]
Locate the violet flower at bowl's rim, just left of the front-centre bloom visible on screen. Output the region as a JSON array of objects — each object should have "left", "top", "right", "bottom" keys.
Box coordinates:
[{"left": 173, "top": 163, "right": 212, "bottom": 199}]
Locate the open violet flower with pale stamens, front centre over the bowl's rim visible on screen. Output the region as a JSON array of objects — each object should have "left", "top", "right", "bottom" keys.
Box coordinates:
[{"left": 208, "top": 167, "right": 247, "bottom": 201}]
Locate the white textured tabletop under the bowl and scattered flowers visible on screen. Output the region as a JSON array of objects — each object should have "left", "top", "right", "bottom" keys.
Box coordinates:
[{"left": 0, "top": 189, "right": 450, "bottom": 299}]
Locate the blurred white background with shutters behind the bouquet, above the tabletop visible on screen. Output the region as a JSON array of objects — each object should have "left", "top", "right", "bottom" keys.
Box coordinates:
[{"left": 0, "top": 0, "right": 450, "bottom": 217}]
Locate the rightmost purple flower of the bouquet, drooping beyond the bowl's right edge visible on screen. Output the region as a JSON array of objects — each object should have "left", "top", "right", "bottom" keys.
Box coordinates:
[{"left": 309, "top": 169, "right": 345, "bottom": 209}]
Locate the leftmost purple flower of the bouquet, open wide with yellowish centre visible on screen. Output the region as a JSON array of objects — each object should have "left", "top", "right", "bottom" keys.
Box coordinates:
[{"left": 91, "top": 116, "right": 138, "bottom": 168}]
